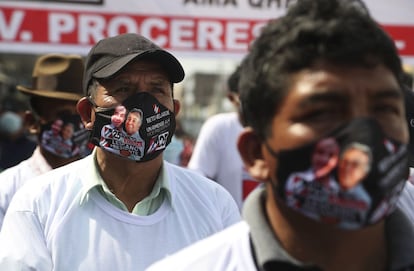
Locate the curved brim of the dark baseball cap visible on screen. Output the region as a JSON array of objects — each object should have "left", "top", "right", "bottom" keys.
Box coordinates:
[{"left": 93, "top": 50, "right": 185, "bottom": 83}]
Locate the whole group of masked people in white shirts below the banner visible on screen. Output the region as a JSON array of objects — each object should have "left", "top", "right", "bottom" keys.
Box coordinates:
[{"left": 0, "top": 0, "right": 414, "bottom": 271}]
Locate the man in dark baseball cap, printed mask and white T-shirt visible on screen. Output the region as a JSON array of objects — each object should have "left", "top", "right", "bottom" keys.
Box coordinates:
[{"left": 0, "top": 34, "right": 240, "bottom": 271}]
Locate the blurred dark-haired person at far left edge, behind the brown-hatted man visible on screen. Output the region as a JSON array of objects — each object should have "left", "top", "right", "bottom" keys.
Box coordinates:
[{"left": 0, "top": 94, "right": 36, "bottom": 171}]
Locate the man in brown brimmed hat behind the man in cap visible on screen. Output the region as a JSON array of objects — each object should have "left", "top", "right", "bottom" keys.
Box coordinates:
[{"left": 0, "top": 53, "right": 90, "bottom": 229}]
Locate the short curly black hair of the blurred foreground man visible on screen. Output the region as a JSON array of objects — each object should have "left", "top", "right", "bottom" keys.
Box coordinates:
[{"left": 239, "top": 0, "right": 402, "bottom": 138}]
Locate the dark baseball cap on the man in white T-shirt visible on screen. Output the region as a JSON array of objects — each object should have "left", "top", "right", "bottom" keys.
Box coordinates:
[{"left": 83, "top": 33, "right": 185, "bottom": 95}]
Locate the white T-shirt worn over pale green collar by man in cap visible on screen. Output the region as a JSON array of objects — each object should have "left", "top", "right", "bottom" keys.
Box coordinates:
[{"left": 0, "top": 152, "right": 240, "bottom": 271}]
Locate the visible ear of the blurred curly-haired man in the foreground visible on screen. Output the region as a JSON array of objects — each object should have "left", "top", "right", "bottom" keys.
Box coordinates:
[{"left": 237, "top": 127, "right": 270, "bottom": 182}]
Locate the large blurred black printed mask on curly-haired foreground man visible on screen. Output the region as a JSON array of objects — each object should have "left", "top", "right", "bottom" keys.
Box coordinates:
[{"left": 266, "top": 118, "right": 409, "bottom": 229}]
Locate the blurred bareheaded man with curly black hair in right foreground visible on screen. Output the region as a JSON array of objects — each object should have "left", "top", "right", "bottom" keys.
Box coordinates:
[{"left": 147, "top": 0, "right": 414, "bottom": 271}]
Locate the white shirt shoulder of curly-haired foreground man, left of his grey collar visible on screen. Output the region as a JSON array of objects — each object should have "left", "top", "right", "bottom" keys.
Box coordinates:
[{"left": 146, "top": 221, "right": 251, "bottom": 271}]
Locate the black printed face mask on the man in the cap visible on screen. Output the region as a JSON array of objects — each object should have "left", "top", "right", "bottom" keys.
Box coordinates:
[{"left": 91, "top": 92, "right": 175, "bottom": 162}]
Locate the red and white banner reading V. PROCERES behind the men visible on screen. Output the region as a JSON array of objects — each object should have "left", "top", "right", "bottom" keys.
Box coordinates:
[{"left": 0, "top": 0, "right": 414, "bottom": 62}]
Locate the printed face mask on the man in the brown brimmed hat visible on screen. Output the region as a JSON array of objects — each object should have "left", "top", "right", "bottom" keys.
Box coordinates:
[{"left": 39, "top": 114, "right": 90, "bottom": 159}]
